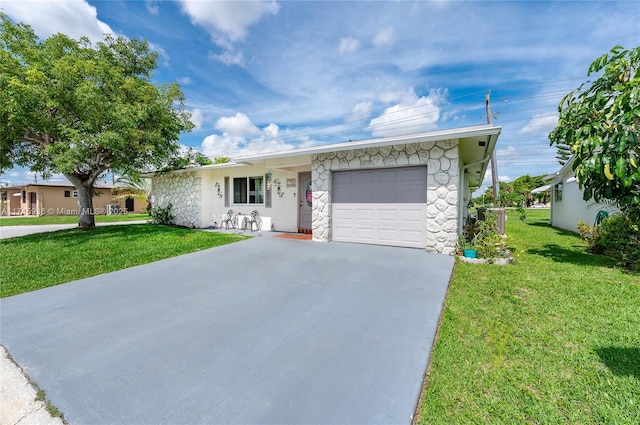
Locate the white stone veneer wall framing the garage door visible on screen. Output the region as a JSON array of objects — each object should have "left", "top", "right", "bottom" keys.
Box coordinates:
[{"left": 311, "top": 140, "right": 458, "bottom": 254}]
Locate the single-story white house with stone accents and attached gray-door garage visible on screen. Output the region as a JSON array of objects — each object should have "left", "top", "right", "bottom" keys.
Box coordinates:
[{"left": 152, "top": 125, "right": 500, "bottom": 254}]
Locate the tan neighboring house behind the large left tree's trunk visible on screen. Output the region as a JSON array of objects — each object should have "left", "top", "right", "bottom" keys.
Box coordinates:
[{"left": 0, "top": 182, "right": 147, "bottom": 216}]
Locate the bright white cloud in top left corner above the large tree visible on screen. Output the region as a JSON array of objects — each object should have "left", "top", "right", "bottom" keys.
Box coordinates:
[{"left": 2, "top": 0, "right": 114, "bottom": 43}]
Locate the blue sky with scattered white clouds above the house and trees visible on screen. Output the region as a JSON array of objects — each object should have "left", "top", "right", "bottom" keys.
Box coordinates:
[{"left": 0, "top": 0, "right": 640, "bottom": 193}]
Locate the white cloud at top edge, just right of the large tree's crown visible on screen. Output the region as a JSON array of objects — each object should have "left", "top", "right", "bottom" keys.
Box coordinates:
[{"left": 180, "top": 0, "right": 280, "bottom": 47}]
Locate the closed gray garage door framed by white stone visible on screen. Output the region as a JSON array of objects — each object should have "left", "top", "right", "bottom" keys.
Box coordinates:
[{"left": 331, "top": 166, "right": 427, "bottom": 248}]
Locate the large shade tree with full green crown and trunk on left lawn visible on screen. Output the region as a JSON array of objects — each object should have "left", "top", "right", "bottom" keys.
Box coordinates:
[{"left": 0, "top": 14, "right": 193, "bottom": 228}]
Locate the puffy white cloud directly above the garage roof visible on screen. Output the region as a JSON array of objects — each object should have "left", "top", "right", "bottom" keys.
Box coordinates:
[{"left": 367, "top": 90, "right": 446, "bottom": 137}]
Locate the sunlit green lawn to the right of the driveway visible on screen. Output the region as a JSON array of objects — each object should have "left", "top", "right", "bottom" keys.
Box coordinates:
[{"left": 416, "top": 209, "right": 640, "bottom": 424}]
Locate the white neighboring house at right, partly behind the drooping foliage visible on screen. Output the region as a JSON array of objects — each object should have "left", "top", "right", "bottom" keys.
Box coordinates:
[{"left": 546, "top": 159, "right": 618, "bottom": 232}]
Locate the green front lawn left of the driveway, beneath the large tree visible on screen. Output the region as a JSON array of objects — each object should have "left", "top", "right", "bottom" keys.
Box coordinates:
[{"left": 0, "top": 224, "right": 245, "bottom": 297}]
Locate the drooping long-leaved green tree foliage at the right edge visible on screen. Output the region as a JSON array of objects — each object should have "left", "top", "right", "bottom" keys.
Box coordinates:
[{"left": 549, "top": 46, "right": 640, "bottom": 223}]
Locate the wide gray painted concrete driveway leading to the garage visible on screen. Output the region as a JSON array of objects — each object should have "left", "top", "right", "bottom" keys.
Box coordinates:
[{"left": 0, "top": 237, "right": 453, "bottom": 425}]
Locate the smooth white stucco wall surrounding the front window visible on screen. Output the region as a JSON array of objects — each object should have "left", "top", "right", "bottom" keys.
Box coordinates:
[{"left": 200, "top": 165, "right": 299, "bottom": 232}]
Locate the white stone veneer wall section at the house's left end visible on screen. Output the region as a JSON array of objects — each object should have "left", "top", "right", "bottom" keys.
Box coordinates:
[{"left": 152, "top": 172, "right": 202, "bottom": 228}]
